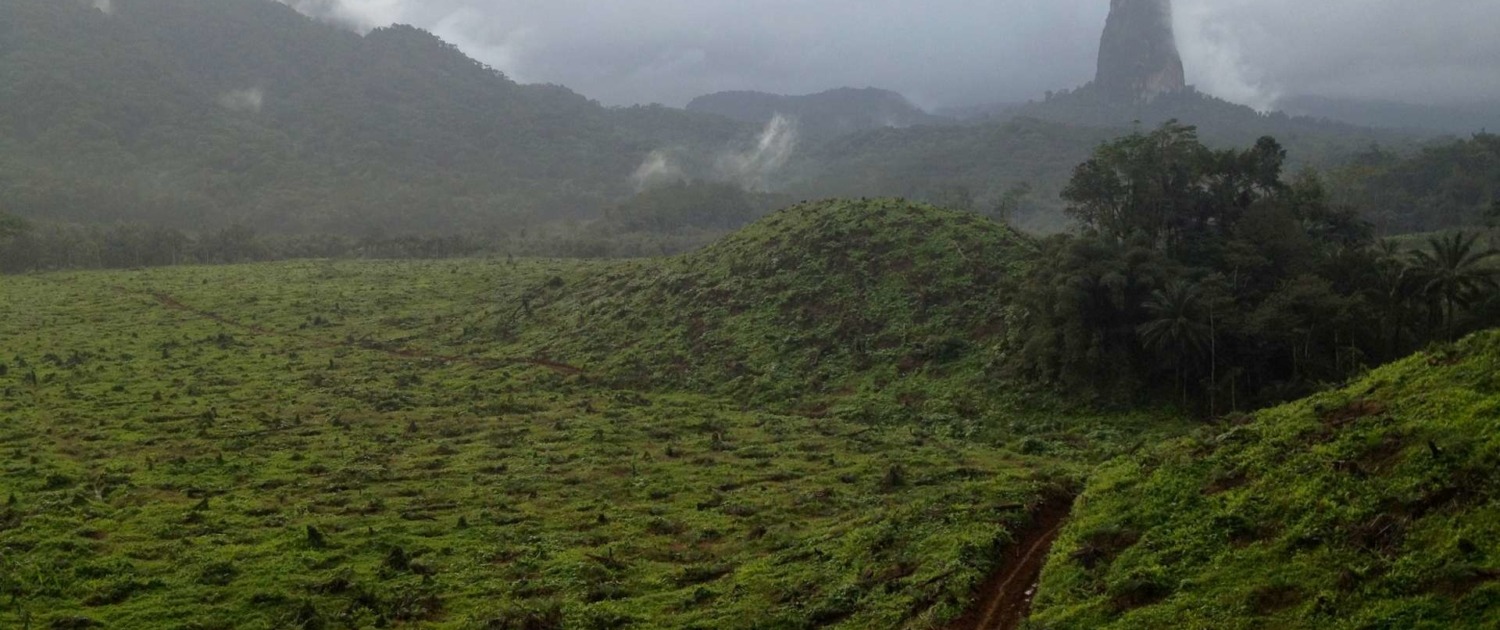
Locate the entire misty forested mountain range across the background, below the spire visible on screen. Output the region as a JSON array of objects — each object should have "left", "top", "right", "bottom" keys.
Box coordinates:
[{"left": 0, "top": 0, "right": 1446, "bottom": 237}]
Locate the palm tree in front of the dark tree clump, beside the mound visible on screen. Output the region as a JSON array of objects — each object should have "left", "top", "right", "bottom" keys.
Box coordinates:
[{"left": 1136, "top": 281, "right": 1214, "bottom": 407}]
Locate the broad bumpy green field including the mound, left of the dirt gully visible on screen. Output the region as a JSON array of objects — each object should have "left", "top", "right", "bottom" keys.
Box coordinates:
[{"left": 0, "top": 201, "right": 1172, "bottom": 629}]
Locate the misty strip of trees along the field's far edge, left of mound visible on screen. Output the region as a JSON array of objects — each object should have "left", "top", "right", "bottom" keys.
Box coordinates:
[{"left": 0, "top": 182, "right": 789, "bottom": 273}]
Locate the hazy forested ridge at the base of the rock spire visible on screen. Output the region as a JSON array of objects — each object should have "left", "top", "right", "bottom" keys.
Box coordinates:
[{"left": 789, "top": 86, "right": 1418, "bottom": 231}]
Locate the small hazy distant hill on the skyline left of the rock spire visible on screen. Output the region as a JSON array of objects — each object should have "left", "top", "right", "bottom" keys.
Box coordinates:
[{"left": 687, "top": 87, "right": 948, "bottom": 140}]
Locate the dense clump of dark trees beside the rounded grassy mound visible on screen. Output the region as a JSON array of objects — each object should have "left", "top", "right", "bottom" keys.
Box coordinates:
[{"left": 1017, "top": 123, "right": 1500, "bottom": 414}]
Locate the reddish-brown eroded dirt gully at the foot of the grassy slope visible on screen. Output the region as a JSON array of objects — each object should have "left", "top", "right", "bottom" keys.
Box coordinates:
[{"left": 947, "top": 494, "right": 1076, "bottom": 630}]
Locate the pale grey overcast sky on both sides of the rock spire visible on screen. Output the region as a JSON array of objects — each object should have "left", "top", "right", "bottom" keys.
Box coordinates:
[{"left": 284, "top": 0, "right": 1500, "bottom": 108}]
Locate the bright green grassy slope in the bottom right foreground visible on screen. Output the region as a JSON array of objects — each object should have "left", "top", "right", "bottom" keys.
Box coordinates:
[{"left": 1031, "top": 333, "right": 1500, "bottom": 630}]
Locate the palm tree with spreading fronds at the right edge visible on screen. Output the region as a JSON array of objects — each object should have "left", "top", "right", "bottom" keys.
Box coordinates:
[{"left": 1412, "top": 233, "right": 1500, "bottom": 339}]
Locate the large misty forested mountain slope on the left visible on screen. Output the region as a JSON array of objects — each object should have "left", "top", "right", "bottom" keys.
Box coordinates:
[{"left": 0, "top": 0, "right": 743, "bottom": 233}]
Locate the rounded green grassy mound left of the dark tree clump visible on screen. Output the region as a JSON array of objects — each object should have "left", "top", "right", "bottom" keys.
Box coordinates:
[{"left": 498, "top": 200, "right": 1034, "bottom": 402}]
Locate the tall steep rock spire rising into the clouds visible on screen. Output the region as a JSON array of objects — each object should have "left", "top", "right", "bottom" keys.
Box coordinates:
[{"left": 1094, "top": 0, "right": 1187, "bottom": 101}]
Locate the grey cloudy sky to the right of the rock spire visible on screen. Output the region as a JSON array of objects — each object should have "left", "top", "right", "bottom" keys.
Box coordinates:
[{"left": 1176, "top": 0, "right": 1500, "bottom": 107}]
